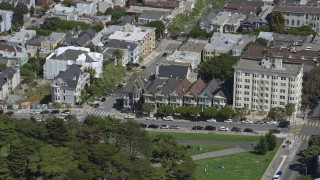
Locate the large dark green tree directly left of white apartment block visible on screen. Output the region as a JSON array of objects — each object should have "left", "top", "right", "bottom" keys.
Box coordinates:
[{"left": 200, "top": 54, "right": 239, "bottom": 81}]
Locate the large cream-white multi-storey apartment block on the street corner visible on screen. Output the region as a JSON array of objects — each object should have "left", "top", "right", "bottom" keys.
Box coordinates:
[{"left": 233, "top": 59, "right": 303, "bottom": 112}]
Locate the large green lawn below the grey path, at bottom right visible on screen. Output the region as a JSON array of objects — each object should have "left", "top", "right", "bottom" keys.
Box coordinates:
[{"left": 195, "top": 145, "right": 280, "bottom": 180}]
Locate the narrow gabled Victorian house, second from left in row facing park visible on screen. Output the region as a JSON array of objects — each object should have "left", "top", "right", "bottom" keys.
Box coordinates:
[{"left": 143, "top": 78, "right": 167, "bottom": 106}]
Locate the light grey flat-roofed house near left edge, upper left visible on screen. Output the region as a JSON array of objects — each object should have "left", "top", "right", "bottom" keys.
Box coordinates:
[{"left": 8, "top": 28, "right": 37, "bottom": 48}]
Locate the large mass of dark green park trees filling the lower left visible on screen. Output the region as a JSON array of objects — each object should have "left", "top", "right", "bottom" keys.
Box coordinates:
[{"left": 0, "top": 116, "right": 195, "bottom": 180}]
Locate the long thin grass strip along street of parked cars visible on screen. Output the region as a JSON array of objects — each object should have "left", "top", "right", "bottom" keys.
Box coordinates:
[{"left": 148, "top": 131, "right": 260, "bottom": 142}]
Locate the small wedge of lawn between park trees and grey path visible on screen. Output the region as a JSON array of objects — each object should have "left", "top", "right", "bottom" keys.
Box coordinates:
[{"left": 183, "top": 144, "right": 235, "bottom": 156}]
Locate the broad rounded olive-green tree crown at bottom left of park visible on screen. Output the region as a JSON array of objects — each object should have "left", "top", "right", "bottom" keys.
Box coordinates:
[{"left": 28, "top": 145, "right": 78, "bottom": 179}]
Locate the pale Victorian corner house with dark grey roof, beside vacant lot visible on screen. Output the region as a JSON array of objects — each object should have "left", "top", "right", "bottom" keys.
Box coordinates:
[{"left": 51, "top": 64, "right": 90, "bottom": 105}]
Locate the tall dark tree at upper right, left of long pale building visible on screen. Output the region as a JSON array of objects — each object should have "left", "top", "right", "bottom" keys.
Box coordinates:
[{"left": 268, "top": 11, "right": 286, "bottom": 33}]
